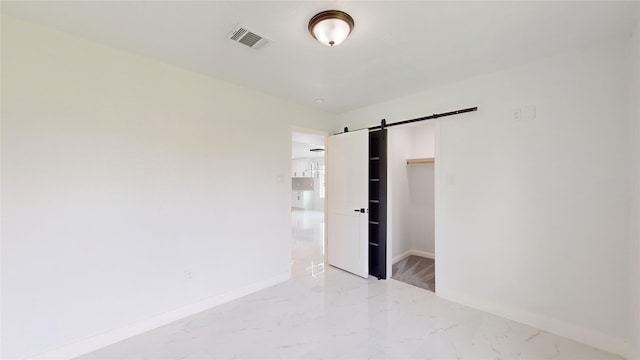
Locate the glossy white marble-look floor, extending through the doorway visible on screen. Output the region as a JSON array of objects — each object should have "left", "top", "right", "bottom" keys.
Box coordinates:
[{"left": 80, "top": 212, "right": 620, "bottom": 360}]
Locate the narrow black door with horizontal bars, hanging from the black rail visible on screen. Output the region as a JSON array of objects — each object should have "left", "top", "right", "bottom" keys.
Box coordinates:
[{"left": 369, "top": 129, "right": 387, "bottom": 279}]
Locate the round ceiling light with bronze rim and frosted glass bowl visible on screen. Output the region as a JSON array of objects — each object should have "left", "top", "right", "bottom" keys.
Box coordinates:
[{"left": 309, "top": 10, "right": 355, "bottom": 46}]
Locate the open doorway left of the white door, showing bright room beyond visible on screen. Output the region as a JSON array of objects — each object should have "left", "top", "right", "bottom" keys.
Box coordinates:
[{"left": 291, "top": 130, "right": 326, "bottom": 277}]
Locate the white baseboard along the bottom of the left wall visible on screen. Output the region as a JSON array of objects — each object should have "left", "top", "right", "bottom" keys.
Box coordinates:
[{"left": 29, "top": 272, "right": 291, "bottom": 359}]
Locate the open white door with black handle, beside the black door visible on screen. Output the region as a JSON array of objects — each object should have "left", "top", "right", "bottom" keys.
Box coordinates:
[{"left": 327, "top": 129, "right": 369, "bottom": 278}]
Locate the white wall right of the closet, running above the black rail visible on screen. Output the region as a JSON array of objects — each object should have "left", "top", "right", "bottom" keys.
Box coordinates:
[{"left": 335, "top": 38, "right": 635, "bottom": 354}]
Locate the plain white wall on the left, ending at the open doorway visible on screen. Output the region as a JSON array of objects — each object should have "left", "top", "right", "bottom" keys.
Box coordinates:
[{"left": 1, "top": 17, "right": 334, "bottom": 358}]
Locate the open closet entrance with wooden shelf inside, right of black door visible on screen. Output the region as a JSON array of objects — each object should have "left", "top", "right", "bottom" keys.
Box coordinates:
[{"left": 387, "top": 121, "right": 437, "bottom": 292}]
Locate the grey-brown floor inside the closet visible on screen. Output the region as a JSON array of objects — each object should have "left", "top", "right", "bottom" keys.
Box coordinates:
[{"left": 391, "top": 255, "right": 436, "bottom": 291}]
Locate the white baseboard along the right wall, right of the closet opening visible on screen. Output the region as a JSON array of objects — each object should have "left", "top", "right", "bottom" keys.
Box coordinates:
[{"left": 437, "top": 285, "right": 633, "bottom": 358}]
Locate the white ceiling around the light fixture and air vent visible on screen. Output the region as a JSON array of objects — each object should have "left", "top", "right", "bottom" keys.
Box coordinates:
[{"left": 2, "top": 1, "right": 638, "bottom": 113}]
